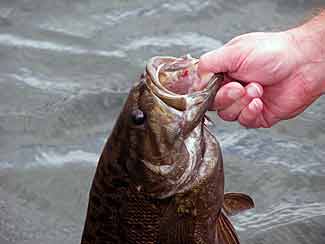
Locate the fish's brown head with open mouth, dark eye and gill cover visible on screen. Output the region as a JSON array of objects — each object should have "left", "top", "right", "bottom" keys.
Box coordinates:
[{"left": 119, "top": 56, "right": 223, "bottom": 197}]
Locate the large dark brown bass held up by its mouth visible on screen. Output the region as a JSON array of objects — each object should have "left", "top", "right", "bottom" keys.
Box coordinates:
[{"left": 81, "top": 55, "right": 254, "bottom": 244}]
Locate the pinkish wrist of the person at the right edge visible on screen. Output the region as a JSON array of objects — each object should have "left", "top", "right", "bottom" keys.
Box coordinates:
[{"left": 287, "top": 11, "right": 325, "bottom": 96}]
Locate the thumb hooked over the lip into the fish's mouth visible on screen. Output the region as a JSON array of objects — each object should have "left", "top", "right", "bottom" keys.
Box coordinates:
[{"left": 198, "top": 45, "right": 237, "bottom": 76}]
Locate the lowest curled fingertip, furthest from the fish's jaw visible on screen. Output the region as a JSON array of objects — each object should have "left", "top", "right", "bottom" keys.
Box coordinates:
[{"left": 238, "top": 98, "right": 263, "bottom": 128}]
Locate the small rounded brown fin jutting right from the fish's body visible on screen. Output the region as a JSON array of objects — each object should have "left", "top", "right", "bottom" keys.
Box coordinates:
[{"left": 223, "top": 192, "right": 255, "bottom": 215}]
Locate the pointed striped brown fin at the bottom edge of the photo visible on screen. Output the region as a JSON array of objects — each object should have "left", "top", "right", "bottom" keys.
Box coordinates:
[{"left": 217, "top": 211, "right": 240, "bottom": 244}]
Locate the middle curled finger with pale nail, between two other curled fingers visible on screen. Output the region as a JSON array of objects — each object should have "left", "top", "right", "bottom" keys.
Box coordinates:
[{"left": 218, "top": 83, "right": 263, "bottom": 121}]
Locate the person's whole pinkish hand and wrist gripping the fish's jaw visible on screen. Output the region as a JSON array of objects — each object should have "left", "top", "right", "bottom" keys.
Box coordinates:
[{"left": 194, "top": 11, "right": 325, "bottom": 128}]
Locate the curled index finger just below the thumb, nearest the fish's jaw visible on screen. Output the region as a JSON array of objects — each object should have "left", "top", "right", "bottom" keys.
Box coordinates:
[{"left": 211, "top": 81, "right": 245, "bottom": 110}]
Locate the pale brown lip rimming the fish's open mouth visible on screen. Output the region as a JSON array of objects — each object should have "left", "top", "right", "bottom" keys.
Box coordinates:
[{"left": 145, "top": 56, "right": 223, "bottom": 111}]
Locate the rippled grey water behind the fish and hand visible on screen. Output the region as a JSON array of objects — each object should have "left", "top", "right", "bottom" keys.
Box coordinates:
[{"left": 0, "top": 0, "right": 325, "bottom": 244}]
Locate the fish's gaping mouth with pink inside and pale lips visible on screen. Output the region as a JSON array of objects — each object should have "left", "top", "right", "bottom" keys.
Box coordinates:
[{"left": 146, "top": 55, "right": 223, "bottom": 111}]
